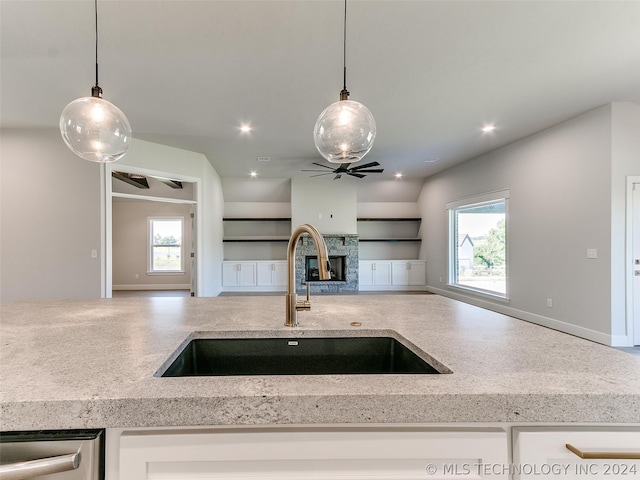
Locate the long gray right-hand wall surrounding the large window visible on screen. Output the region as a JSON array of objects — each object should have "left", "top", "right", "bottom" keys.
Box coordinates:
[{"left": 419, "top": 106, "right": 612, "bottom": 343}]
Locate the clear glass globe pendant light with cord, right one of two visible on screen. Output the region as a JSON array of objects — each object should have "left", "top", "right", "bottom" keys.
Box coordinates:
[{"left": 313, "top": 0, "right": 376, "bottom": 163}]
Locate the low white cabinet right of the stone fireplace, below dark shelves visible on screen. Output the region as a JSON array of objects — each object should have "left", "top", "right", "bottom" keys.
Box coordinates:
[{"left": 359, "top": 260, "right": 426, "bottom": 291}]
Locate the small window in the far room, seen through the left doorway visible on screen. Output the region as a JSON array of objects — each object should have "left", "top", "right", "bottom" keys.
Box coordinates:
[{"left": 149, "top": 217, "right": 184, "bottom": 273}]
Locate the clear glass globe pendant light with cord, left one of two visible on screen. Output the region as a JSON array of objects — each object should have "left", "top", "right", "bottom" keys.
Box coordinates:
[{"left": 60, "top": 0, "right": 131, "bottom": 163}]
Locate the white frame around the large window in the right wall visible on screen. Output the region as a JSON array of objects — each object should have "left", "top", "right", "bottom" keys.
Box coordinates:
[{"left": 446, "top": 190, "right": 511, "bottom": 303}]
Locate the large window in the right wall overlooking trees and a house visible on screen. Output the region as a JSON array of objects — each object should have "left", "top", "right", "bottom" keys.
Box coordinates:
[{"left": 447, "top": 191, "right": 509, "bottom": 298}]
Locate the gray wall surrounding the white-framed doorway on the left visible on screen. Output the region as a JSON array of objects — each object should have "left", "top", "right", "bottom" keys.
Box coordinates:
[{"left": 0, "top": 129, "right": 224, "bottom": 303}]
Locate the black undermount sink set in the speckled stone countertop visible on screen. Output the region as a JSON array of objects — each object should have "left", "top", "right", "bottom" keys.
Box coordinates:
[{"left": 156, "top": 336, "right": 451, "bottom": 377}]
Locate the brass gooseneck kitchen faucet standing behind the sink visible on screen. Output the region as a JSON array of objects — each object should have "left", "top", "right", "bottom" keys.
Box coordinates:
[{"left": 284, "top": 223, "right": 330, "bottom": 327}]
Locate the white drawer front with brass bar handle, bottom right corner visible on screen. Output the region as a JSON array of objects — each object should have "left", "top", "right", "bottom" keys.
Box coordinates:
[{"left": 511, "top": 427, "right": 640, "bottom": 480}]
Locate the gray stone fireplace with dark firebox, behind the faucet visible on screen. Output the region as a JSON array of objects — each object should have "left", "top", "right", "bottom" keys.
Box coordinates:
[{"left": 296, "top": 234, "right": 358, "bottom": 293}]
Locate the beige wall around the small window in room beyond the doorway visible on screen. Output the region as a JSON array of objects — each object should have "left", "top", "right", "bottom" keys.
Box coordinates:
[{"left": 112, "top": 198, "right": 193, "bottom": 290}]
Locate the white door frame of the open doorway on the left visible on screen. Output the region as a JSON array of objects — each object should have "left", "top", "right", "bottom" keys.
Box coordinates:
[{"left": 100, "top": 163, "right": 202, "bottom": 298}]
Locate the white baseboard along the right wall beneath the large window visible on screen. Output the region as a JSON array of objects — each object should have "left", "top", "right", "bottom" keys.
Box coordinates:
[{"left": 427, "top": 285, "right": 614, "bottom": 346}]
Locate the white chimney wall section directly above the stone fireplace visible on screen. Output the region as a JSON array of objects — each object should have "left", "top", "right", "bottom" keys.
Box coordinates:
[{"left": 291, "top": 178, "right": 358, "bottom": 234}]
